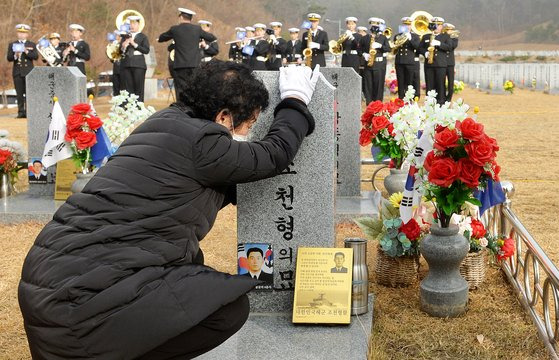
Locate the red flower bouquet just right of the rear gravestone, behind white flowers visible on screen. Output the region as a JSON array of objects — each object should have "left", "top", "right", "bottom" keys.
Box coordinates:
[{"left": 359, "top": 99, "right": 407, "bottom": 168}]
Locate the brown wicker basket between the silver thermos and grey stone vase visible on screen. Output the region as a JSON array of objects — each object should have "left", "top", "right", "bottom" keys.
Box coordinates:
[{"left": 375, "top": 245, "right": 419, "bottom": 287}]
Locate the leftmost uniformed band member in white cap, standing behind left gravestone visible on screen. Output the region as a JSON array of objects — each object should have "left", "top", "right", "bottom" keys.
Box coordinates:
[{"left": 7, "top": 24, "right": 39, "bottom": 118}]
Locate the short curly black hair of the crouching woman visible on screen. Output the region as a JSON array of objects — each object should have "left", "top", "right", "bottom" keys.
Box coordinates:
[{"left": 179, "top": 60, "right": 269, "bottom": 127}]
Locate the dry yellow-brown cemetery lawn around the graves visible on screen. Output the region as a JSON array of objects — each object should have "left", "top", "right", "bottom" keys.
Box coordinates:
[{"left": 0, "top": 89, "right": 559, "bottom": 360}]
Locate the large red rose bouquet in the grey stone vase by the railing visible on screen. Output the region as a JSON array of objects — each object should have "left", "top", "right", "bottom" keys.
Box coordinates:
[{"left": 423, "top": 118, "right": 500, "bottom": 227}]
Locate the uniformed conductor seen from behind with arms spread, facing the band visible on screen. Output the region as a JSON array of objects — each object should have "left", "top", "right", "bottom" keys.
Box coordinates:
[{"left": 158, "top": 8, "right": 216, "bottom": 99}]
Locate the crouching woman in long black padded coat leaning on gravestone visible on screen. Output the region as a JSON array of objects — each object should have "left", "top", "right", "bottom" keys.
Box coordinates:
[{"left": 19, "top": 61, "right": 318, "bottom": 360}]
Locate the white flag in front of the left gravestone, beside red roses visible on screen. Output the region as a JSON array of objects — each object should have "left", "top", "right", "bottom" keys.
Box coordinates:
[{"left": 41, "top": 100, "right": 72, "bottom": 168}]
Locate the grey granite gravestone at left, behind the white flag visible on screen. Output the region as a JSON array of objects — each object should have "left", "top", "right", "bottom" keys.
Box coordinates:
[{"left": 25, "top": 66, "right": 87, "bottom": 196}]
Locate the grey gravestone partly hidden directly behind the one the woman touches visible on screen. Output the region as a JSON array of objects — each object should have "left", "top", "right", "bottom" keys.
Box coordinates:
[{"left": 321, "top": 67, "right": 361, "bottom": 196}]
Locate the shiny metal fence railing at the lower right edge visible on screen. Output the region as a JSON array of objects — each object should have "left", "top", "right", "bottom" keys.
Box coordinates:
[{"left": 484, "top": 182, "right": 559, "bottom": 359}]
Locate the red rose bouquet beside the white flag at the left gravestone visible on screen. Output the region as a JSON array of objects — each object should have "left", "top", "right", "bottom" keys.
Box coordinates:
[{"left": 64, "top": 103, "right": 103, "bottom": 173}]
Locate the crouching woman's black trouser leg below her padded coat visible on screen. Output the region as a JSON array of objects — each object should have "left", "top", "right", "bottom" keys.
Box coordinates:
[{"left": 137, "top": 295, "right": 249, "bottom": 360}]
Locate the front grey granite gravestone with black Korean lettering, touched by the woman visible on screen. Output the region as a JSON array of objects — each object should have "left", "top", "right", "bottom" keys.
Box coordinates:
[{"left": 237, "top": 71, "right": 336, "bottom": 312}]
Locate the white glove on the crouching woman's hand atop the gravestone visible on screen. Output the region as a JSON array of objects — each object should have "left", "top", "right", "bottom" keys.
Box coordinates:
[{"left": 279, "top": 65, "right": 324, "bottom": 105}]
